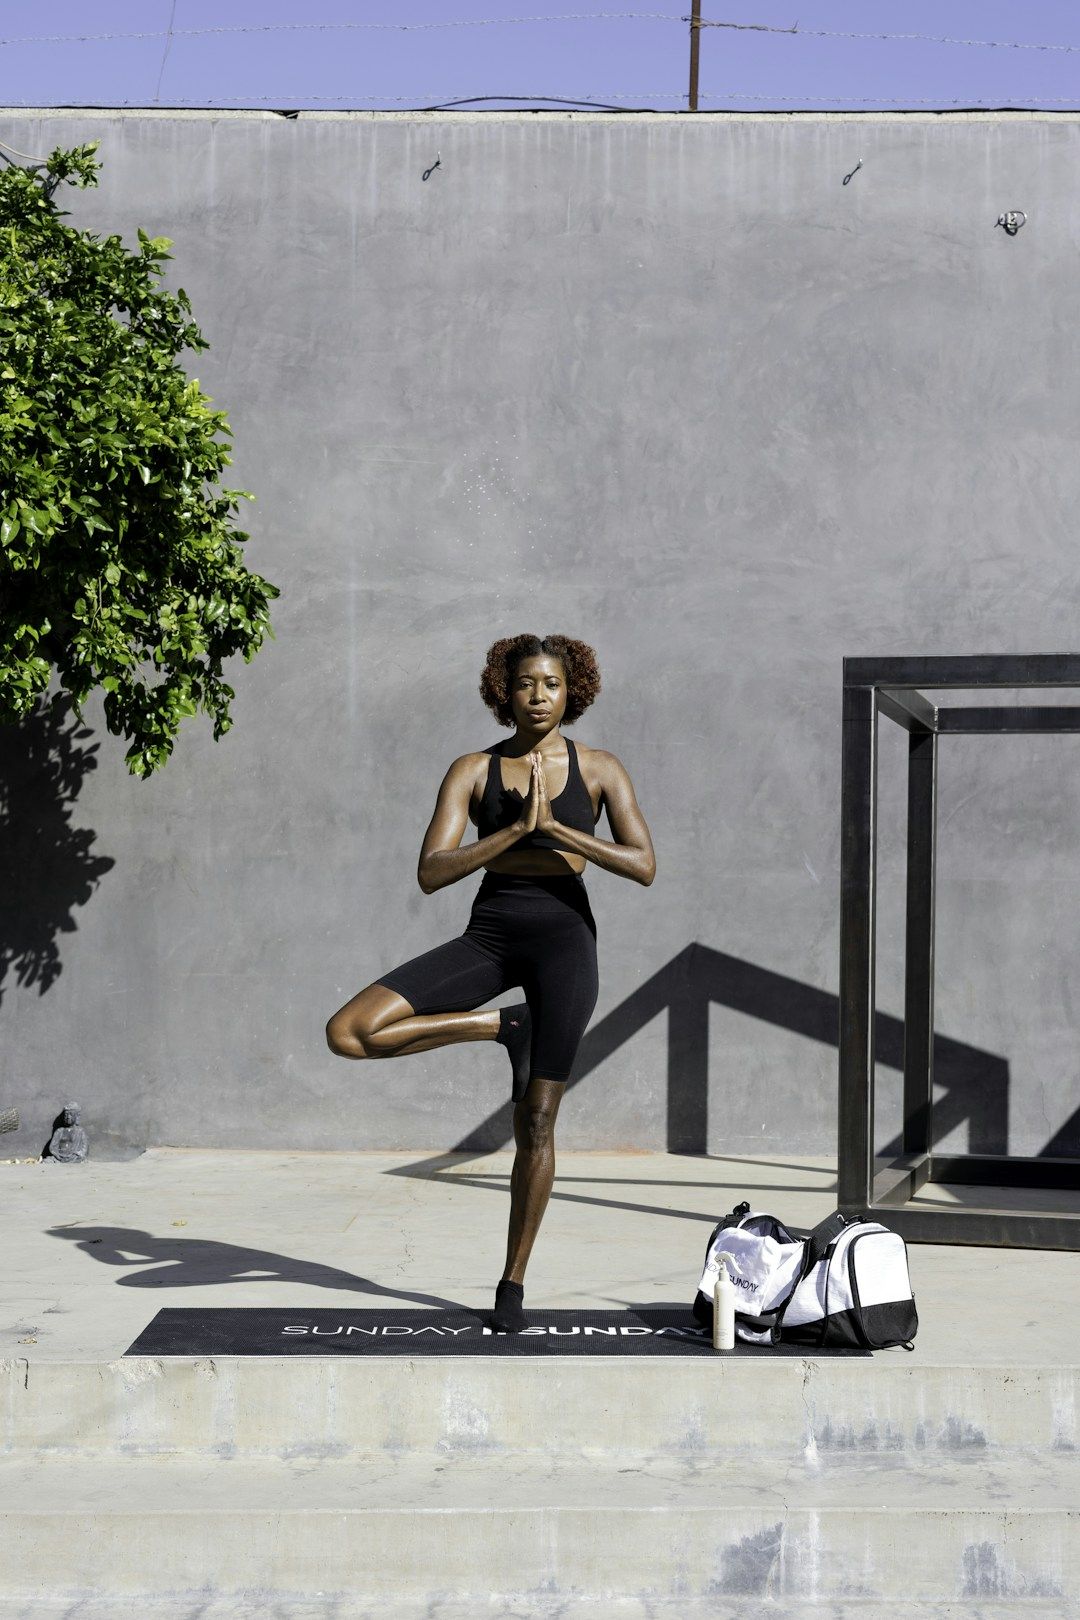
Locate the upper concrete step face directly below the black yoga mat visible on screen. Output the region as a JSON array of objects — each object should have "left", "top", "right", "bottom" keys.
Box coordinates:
[{"left": 0, "top": 1349, "right": 1080, "bottom": 1458}]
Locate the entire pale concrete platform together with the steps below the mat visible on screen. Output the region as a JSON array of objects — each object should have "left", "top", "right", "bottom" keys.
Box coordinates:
[{"left": 0, "top": 1149, "right": 1080, "bottom": 1620}]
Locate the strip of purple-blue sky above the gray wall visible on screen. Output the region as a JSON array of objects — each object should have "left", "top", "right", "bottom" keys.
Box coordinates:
[{"left": 0, "top": 0, "right": 1080, "bottom": 112}]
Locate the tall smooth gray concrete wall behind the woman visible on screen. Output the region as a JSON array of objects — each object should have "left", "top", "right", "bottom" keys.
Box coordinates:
[{"left": 0, "top": 112, "right": 1080, "bottom": 1157}]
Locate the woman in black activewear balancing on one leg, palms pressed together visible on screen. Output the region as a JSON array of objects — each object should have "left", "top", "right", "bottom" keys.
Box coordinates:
[{"left": 327, "top": 635, "right": 656, "bottom": 1332}]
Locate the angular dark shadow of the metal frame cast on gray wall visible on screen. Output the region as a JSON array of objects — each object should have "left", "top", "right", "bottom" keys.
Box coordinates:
[{"left": 397, "top": 943, "right": 1080, "bottom": 1175}]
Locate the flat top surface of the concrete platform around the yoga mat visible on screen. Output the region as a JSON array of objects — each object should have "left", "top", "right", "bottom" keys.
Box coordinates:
[{"left": 0, "top": 1147, "right": 1080, "bottom": 1367}]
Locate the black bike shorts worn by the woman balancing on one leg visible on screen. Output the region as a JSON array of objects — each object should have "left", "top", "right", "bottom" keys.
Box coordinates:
[{"left": 376, "top": 872, "right": 599, "bottom": 1082}]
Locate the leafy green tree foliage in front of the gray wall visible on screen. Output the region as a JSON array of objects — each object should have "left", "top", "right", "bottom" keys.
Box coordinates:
[{"left": 0, "top": 143, "right": 280, "bottom": 778}]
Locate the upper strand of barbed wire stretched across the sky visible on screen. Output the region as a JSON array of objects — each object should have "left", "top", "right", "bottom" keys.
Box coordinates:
[{"left": 0, "top": 11, "right": 1080, "bottom": 53}]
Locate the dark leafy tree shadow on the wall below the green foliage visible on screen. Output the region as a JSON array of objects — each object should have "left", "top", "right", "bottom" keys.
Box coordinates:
[{"left": 0, "top": 693, "right": 115, "bottom": 1003}]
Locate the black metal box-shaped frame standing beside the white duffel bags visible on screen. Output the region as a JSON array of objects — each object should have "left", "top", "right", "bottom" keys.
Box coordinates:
[{"left": 839, "top": 653, "right": 1080, "bottom": 1249}]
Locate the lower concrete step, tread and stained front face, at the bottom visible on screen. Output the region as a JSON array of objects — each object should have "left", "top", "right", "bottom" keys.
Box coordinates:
[{"left": 0, "top": 1448, "right": 1080, "bottom": 1615}]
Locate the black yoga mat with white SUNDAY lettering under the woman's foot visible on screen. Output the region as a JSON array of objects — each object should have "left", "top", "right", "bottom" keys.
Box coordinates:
[{"left": 125, "top": 1304, "right": 870, "bottom": 1359}]
